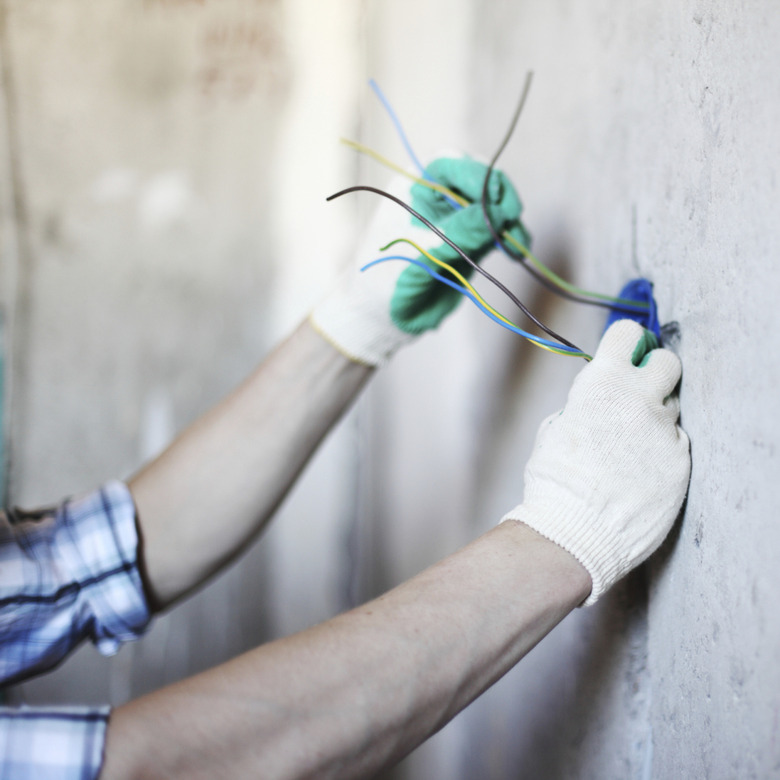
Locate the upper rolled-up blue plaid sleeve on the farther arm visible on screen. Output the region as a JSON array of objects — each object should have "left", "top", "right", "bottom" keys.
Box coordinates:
[{"left": 0, "top": 482, "right": 150, "bottom": 685}]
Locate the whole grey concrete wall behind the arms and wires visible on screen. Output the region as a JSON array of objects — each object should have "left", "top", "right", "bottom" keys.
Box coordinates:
[{"left": 0, "top": 0, "right": 780, "bottom": 780}]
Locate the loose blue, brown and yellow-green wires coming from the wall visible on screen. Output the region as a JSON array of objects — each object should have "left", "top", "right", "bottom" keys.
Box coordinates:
[{"left": 328, "top": 73, "right": 649, "bottom": 360}]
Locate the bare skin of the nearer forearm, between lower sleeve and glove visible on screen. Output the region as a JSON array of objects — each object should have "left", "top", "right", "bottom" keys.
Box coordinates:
[{"left": 101, "top": 522, "right": 591, "bottom": 780}]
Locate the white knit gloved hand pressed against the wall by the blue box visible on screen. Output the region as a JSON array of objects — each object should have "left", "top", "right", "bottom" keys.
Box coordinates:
[{"left": 502, "top": 320, "right": 691, "bottom": 604}]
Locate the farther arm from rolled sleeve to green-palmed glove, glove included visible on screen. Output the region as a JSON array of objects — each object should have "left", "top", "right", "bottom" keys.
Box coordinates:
[{"left": 129, "top": 157, "right": 528, "bottom": 610}]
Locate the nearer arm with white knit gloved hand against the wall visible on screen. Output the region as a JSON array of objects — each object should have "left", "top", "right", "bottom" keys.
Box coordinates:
[{"left": 103, "top": 321, "right": 690, "bottom": 780}]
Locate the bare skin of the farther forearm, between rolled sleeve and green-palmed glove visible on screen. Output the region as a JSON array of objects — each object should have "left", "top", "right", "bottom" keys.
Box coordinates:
[{"left": 129, "top": 316, "right": 371, "bottom": 607}]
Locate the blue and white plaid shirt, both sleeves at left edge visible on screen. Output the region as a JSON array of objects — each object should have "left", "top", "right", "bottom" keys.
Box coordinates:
[{"left": 0, "top": 482, "right": 150, "bottom": 780}]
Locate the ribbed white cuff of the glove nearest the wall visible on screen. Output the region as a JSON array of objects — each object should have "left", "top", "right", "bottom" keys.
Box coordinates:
[{"left": 501, "top": 497, "right": 632, "bottom": 606}]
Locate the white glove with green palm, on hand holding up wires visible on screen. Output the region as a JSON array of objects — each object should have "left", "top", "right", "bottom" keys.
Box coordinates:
[{"left": 310, "top": 157, "right": 530, "bottom": 366}]
